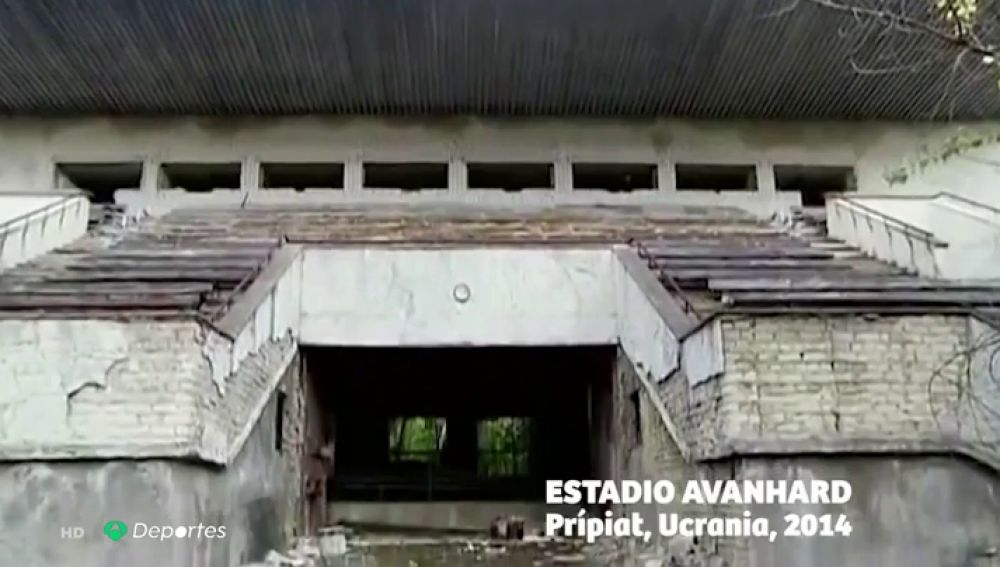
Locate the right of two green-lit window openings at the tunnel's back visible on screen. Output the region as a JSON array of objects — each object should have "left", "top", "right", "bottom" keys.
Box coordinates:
[{"left": 478, "top": 417, "right": 531, "bottom": 478}]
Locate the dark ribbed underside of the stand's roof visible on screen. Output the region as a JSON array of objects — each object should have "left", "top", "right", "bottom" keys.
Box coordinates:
[{"left": 0, "top": 0, "right": 1000, "bottom": 120}]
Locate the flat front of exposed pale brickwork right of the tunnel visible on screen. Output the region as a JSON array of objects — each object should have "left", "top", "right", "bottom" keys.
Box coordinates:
[{"left": 719, "top": 316, "right": 968, "bottom": 452}]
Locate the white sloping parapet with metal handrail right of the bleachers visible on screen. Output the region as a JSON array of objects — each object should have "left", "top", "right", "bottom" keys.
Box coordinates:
[{"left": 827, "top": 198, "right": 948, "bottom": 278}]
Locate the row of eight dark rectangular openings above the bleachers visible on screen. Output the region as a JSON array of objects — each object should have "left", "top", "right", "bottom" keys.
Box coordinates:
[{"left": 56, "top": 162, "right": 854, "bottom": 204}]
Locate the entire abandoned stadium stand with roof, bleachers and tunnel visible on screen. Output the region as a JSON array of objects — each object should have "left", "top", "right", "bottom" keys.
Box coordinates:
[{"left": 0, "top": 0, "right": 1000, "bottom": 567}]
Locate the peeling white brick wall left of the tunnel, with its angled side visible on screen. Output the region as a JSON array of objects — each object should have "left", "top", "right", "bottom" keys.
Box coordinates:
[{"left": 0, "top": 320, "right": 297, "bottom": 463}]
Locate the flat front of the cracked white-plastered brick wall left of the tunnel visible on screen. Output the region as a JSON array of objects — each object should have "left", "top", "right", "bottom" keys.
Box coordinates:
[{"left": 0, "top": 320, "right": 209, "bottom": 458}]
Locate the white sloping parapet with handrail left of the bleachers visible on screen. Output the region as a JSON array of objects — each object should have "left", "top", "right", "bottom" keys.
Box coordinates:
[{"left": 0, "top": 193, "right": 90, "bottom": 271}]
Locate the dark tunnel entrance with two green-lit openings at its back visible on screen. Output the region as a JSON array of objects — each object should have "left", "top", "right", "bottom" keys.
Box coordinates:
[{"left": 304, "top": 346, "right": 616, "bottom": 527}]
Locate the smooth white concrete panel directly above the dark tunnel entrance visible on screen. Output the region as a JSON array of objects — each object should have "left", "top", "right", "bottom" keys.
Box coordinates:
[{"left": 301, "top": 248, "right": 617, "bottom": 346}]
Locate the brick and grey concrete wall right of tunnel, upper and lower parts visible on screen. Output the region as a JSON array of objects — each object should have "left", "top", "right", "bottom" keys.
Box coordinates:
[{"left": 609, "top": 316, "right": 1000, "bottom": 567}]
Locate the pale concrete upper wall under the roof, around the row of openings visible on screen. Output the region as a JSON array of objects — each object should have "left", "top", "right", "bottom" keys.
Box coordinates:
[{"left": 0, "top": 117, "right": 1000, "bottom": 209}]
